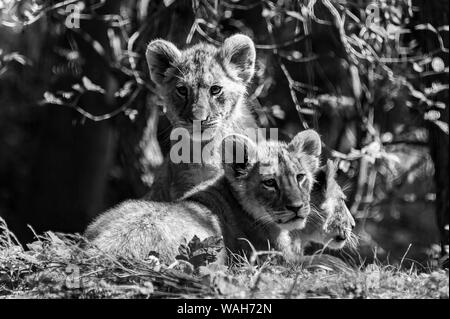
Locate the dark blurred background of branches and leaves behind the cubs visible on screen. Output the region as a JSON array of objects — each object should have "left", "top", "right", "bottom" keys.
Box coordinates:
[{"left": 0, "top": 0, "right": 449, "bottom": 267}]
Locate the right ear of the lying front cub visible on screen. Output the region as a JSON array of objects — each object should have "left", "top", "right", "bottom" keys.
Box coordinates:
[{"left": 289, "top": 130, "right": 322, "bottom": 171}]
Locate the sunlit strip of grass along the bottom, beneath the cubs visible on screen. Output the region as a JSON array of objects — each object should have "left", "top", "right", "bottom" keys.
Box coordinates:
[{"left": 0, "top": 219, "right": 449, "bottom": 299}]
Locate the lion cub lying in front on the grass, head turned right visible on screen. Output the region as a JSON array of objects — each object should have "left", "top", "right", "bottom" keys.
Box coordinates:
[{"left": 85, "top": 130, "right": 321, "bottom": 263}]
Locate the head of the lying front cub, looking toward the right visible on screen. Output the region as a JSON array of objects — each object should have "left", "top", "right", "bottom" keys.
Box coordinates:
[{"left": 224, "top": 130, "right": 321, "bottom": 230}]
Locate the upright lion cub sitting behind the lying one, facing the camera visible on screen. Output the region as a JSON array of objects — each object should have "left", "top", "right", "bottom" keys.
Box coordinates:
[{"left": 146, "top": 34, "right": 256, "bottom": 201}]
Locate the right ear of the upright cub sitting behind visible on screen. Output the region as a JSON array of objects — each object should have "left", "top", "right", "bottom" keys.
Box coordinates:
[{"left": 220, "top": 34, "right": 256, "bottom": 83}]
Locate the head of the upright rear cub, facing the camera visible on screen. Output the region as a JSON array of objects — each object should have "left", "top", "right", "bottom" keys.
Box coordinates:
[{"left": 146, "top": 34, "right": 256, "bottom": 139}]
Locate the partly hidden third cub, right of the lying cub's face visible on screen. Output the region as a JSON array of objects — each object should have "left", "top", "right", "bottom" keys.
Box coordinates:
[{"left": 301, "top": 160, "right": 356, "bottom": 249}]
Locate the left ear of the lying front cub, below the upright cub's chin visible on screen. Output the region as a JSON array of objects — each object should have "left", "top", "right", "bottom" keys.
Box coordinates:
[{"left": 221, "top": 136, "right": 257, "bottom": 179}]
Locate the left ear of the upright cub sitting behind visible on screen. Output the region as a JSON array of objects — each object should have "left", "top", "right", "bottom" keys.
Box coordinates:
[{"left": 145, "top": 39, "right": 181, "bottom": 85}]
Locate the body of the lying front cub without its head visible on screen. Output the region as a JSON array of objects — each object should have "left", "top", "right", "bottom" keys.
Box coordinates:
[{"left": 86, "top": 178, "right": 277, "bottom": 264}]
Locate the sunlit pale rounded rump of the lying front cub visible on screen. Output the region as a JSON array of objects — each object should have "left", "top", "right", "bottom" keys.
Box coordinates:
[{"left": 85, "top": 200, "right": 222, "bottom": 263}]
